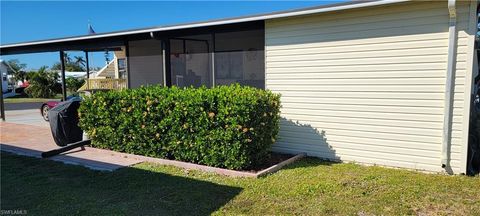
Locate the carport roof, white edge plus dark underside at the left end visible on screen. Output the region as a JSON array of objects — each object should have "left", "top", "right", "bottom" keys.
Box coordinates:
[{"left": 0, "top": 0, "right": 408, "bottom": 55}]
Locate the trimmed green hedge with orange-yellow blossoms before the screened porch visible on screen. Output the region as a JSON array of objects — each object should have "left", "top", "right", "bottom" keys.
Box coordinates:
[{"left": 79, "top": 85, "right": 280, "bottom": 170}]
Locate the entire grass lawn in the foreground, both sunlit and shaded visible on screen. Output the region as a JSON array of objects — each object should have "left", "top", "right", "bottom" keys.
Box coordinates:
[{"left": 1, "top": 152, "right": 480, "bottom": 215}]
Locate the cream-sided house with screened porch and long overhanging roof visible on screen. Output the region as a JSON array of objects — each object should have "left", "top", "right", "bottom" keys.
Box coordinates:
[{"left": 0, "top": 0, "right": 478, "bottom": 173}]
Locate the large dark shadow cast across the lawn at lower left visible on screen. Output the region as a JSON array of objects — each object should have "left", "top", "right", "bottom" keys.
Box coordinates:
[{"left": 1, "top": 152, "right": 242, "bottom": 215}]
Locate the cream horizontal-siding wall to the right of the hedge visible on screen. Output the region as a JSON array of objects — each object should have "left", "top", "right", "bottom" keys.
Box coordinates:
[{"left": 265, "top": 2, "right": 473, "bottom": 173}]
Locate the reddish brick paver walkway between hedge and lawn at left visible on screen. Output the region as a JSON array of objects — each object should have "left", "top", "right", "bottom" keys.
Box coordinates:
[{"left": 0, "top": 122, "right": 144, "bottom": 171}]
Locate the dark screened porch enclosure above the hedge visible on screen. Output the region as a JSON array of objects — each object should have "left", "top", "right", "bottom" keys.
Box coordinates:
[{"left": 128, "top": 23, "right": 265, "bottom": 89}]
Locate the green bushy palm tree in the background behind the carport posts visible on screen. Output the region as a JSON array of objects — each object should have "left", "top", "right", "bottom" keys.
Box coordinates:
[{"left": 25, "top": 66, "right": 62, "bottom": 98}]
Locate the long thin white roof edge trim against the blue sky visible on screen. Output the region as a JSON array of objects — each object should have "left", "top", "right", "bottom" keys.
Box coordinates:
[{"left": 0, "top": 0, "right": 409, "bottom": 54}]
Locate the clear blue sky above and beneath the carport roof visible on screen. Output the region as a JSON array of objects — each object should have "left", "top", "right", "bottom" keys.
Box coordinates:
[{"left": 0, "top": 0, "right": 339, "bottom": 69}]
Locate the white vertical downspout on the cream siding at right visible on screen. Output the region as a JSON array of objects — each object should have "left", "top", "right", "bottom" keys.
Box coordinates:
[{"left": 441, "top": 0, "right": 457, "bottom": 168}]
